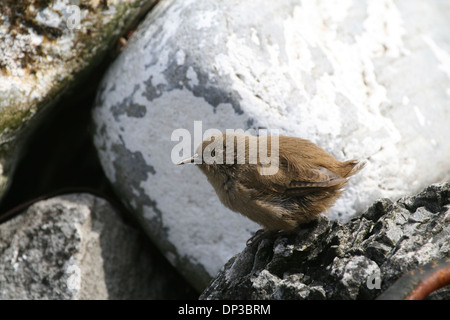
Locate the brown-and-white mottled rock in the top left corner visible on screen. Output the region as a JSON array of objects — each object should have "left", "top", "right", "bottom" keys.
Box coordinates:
[{"left": 0, "top": 0, "right": 156, "bottom": 199}]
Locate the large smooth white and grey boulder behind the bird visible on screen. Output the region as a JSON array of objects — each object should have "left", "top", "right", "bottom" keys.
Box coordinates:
[{"left": 90, "top": 0, "right": 450, "bottom": 288}]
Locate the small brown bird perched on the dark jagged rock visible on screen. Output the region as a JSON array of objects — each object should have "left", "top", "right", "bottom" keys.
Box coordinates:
[{"left": 178, "top": 133, "right": 364, "bottom": 231}]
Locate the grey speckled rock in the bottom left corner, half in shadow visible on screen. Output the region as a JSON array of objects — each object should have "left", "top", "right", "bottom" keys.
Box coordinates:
[{"left": 0, "top": 194, "right": 194, "bottom": 299}]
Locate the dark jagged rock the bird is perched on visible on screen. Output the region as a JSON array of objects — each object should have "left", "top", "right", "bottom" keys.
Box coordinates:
[{"left": 200, "top": 183, "right": 450, "bottom": 299}]
